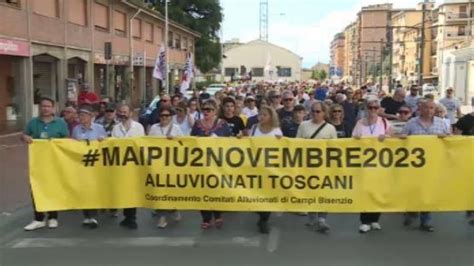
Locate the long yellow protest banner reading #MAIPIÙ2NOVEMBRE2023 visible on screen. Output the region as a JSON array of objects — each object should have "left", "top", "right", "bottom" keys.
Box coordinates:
[{"left": 30, "top": 136, "right": 474, "bottom": 212}]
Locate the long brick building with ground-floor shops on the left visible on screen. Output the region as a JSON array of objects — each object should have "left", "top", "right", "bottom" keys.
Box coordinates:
[{"left": 0, "top": 0, "right": 199, "bottom": 128}]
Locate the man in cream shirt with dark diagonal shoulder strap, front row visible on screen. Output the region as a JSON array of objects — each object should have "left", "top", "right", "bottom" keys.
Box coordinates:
[{"left": 296, "top": 102, "right": 337, "bottom": 233}]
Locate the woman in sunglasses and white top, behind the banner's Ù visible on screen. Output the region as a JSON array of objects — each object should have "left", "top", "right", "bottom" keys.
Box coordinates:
[{"left": 148, "top": 106, "right": 183, "bottom": 229}]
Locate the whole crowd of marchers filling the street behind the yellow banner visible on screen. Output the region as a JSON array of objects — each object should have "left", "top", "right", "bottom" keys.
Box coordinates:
[{"left": 19, "top": 82, "right": 474, "bottom": 233}]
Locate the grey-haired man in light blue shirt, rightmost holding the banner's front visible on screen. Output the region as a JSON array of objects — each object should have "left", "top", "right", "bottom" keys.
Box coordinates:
[{"left": 400, "top": 99, "right": 450, "bottom": 232}]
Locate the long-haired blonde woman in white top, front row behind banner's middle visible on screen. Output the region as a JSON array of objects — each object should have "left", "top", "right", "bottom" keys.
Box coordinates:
[{"left": 250, "top": 105, "right": 283, "bottom": 234}]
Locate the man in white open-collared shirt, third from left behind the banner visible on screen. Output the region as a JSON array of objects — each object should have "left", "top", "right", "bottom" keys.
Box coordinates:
[{"left": 112, "top": 104, "right": 145, "bottom": 229}]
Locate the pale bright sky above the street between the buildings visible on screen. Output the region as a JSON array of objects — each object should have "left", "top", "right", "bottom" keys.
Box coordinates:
[{"left": 220, "top": 0, "right": 443, "bottom": 67}]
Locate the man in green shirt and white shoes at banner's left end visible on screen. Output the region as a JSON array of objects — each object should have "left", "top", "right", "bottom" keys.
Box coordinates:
[{"left": 22, "top": 98, "right": 69, "bottom": 231}]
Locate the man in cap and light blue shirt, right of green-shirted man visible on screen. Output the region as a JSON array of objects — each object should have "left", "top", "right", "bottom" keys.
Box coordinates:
[{"left": 72, "top": 105, "right": 107, "bottom": 229}]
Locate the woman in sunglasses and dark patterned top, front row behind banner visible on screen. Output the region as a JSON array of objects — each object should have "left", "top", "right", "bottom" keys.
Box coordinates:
[{"left": 191, "top": 99, "right": 232, "bottom": 229}]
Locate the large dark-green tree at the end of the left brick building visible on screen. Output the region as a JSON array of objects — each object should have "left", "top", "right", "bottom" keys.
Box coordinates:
[{"left": 155, "top": 0, "right": 223, "bottom": 73}]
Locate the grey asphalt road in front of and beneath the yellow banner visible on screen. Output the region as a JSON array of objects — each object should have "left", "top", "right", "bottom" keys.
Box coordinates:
[{"left": 0, "top": 208, "right": 474, "bottom": 266}]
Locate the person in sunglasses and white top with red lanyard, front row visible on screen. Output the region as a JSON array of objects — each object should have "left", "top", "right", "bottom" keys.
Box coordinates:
[{"left": 352, "top": 99, "right": 391, "bottom": 233}]
